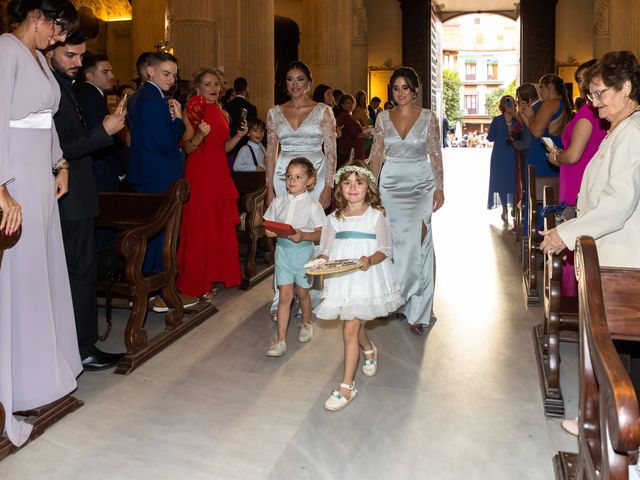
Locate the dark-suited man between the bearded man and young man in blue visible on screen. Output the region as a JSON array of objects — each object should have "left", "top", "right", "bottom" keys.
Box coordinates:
[{"left": 74, "top": 55, "right": 126, "bottom": 192}]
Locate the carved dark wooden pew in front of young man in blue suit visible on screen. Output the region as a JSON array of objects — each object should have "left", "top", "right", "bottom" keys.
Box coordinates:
[{"left": 96, "top": 179, "right": 217, "bottom": 374}]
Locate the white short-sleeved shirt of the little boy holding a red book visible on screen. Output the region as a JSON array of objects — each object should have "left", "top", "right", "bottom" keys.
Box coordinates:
[{"left": 263, "top": 192, "right": 327, "bottom": 232}]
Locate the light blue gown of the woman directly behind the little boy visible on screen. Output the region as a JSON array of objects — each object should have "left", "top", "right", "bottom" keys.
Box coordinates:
[{"left": 267, "top": 103, "right": 336, "bottom": 312}]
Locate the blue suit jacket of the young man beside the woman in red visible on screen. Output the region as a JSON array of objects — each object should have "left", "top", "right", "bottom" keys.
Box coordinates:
[{"left": 128, "top": 82, "right": 185, "bottom": 192}]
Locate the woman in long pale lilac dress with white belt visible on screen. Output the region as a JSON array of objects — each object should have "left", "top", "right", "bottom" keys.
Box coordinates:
[{"left": 0, "top": 0, "right": 82, "bottom": 445}]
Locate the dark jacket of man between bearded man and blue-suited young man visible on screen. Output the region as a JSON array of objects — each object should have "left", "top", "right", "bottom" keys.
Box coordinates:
[{"left": 74, "top": 82, "right": 126, "bottom": 192}]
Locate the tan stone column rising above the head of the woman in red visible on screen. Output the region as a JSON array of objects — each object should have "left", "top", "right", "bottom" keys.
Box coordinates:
[{"left": 169, "top": 0, "right": 221, "bottom": 79}]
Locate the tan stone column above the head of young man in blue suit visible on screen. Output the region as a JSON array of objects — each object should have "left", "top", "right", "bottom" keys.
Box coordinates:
[{"left": 131, "top": 0, "right": 166, "bottom": 77}]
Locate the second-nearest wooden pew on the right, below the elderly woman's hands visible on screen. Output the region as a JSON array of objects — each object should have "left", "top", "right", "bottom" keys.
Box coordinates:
[{"left": 533, "top": 185, "right": 578, "bottom": 417}]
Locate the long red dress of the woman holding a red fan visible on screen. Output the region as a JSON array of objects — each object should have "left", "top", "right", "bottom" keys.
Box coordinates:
[{"left": 176, "top": 96, "right": 242, "bottom": 296}]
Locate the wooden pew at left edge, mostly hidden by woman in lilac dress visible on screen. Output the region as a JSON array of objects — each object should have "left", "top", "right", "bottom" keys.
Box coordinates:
[{"left": 0, "top": 215, "right": 84, "bottom": 460}]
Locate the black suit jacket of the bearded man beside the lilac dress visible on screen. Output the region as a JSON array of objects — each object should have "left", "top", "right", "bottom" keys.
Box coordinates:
[{"left": 53, "top": 71, "right": 113, "bottom": 220}]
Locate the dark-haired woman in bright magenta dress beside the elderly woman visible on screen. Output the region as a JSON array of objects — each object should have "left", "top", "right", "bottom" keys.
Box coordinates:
[{"left": 547, "top": 60, "right": 610, "bottom": 297}]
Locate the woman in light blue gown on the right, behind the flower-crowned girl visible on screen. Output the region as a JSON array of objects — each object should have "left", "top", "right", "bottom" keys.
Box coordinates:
[{"left": 370, "top": 67, "right": 444, "bottom": 335}]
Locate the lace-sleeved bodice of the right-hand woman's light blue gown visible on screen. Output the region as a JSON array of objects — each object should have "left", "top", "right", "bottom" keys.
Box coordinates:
[{"left": 369, "top": 108, "right": 444, "bottom": 190}]
